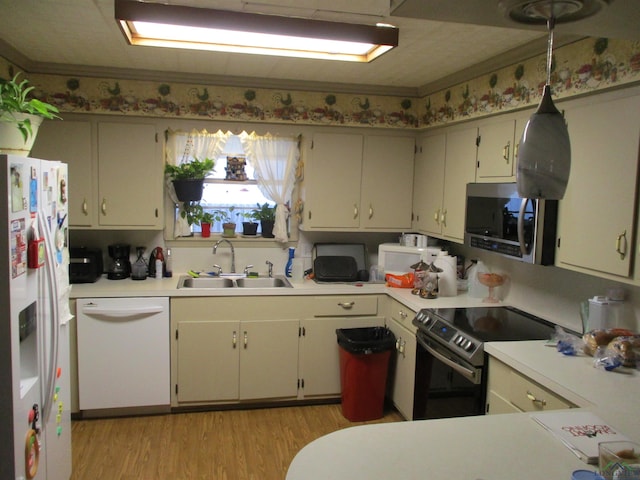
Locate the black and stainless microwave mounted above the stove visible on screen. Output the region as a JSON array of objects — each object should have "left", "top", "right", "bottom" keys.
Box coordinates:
[{"left": 464, "top": 183, "right": 558, "bottom": 265}]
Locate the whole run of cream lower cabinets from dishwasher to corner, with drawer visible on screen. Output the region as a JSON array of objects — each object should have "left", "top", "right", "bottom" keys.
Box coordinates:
[{"left": 171, "top": 295, "right": 384, "bottom": 407}]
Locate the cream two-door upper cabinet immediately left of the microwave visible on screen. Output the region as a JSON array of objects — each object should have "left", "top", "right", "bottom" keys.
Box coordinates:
[{"left": 414, "top": 125, "right": 478, "bottom": 243}]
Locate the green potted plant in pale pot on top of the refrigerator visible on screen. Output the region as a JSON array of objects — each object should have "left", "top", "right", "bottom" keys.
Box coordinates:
[{"left": 0, "top": 73, "right": 60, "bottom": 157}]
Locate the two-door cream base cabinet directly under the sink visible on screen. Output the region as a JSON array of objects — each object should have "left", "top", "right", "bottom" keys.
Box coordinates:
[{"left": 171, "top": 297, "right": 299, "bottom": 405}]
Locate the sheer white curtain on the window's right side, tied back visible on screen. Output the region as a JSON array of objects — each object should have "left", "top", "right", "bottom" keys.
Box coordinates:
[{"left": 240, "top": 132, "right": 300, "bottom": 243}]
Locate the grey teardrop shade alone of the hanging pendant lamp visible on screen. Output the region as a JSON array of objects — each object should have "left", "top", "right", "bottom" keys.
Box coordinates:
[{"left": 516, "top": 85, "right": 571, "bottom": 200}]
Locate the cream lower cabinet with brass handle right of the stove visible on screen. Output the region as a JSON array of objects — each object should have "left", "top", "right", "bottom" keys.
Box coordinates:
[{"left": 485, "top": 357, "right": 577, "bottom": 415}]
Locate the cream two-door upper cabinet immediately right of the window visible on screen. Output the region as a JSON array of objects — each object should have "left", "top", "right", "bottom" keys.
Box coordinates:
[{"left": 300, "top": 133, "right": 415, "bottom": 231}]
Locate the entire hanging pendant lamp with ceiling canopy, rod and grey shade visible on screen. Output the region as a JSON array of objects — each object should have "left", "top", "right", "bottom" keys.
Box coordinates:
[{"left": 499, "top": 0, "right": 612, "bottom": 200}]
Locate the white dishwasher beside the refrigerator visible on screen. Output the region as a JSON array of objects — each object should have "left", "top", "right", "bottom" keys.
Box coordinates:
[{"left": 76, "top": 297, "right": 171, "bottom": 410}]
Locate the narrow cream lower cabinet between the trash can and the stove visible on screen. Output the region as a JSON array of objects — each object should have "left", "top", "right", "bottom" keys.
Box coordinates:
[{"left": 386, "top": 299, "right": 417, "bottom": 420}]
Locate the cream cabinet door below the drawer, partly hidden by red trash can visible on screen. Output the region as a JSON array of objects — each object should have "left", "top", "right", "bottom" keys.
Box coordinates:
[{"left": 300, "top": 317, "right": 384, "bottom": 397}]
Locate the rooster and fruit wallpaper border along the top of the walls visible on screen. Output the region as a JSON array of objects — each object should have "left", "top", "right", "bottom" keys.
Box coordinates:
[{"left": 0, "top": 38, "right": 640, "bottom": 129}]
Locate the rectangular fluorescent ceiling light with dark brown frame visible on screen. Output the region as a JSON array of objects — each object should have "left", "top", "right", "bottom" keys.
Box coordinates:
[{"left": 115, "top": 0, "right": 398, "bottom": 62}]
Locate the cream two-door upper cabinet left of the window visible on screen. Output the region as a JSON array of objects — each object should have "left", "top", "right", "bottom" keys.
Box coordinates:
[{"left": 32, "top": 119, "right": 164, "bottom": 230}]
